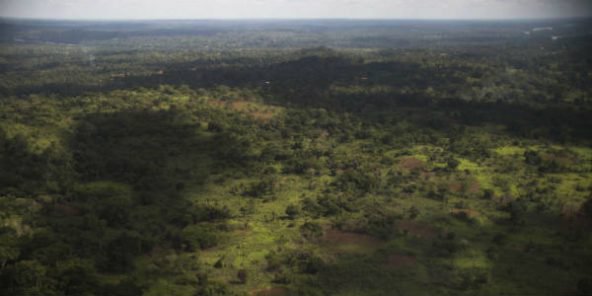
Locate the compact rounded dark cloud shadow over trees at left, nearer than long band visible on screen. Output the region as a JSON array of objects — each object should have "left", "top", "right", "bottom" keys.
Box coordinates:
[{"left": 72, "top": 111, "right": 207, "bottom": 193}]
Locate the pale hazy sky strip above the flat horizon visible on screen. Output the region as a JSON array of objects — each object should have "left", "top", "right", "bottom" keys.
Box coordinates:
[{"left": 0, "top": 0, "right": 592, "bottom": 19}]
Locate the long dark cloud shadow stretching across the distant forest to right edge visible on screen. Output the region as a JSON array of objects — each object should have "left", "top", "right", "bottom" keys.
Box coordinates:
[{"left": 6, "top": 51, "right": 592, "bottom": 144}]
